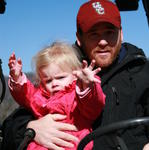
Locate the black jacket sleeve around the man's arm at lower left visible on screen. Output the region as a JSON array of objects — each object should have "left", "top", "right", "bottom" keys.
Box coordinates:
[{"left": 1, "top": 108, "right": 34, "bottom": 150}]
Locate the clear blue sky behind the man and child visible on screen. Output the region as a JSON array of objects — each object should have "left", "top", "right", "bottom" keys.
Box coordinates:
[{"left": 0, "top": 0, "right": 149, "bottom": 75}]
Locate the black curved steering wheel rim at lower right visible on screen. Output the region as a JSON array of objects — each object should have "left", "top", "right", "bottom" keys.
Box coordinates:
[{"left": 77, "top": 117, "right": 149, "bottom": 150}]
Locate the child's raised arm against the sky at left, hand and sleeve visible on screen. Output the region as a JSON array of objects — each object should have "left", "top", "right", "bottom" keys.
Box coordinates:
[{"left": 8, "top": 53, "right": 35, "bottom": 107}]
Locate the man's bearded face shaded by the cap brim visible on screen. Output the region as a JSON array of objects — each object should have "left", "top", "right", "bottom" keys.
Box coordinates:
[{"left": 77, "top": 22, "right": 123, "bottom": 68}]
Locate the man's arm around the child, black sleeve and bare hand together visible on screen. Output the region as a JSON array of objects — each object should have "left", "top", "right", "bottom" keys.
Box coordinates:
[{"left": 2, "top": 108, "right": 78, "bottom": 150}]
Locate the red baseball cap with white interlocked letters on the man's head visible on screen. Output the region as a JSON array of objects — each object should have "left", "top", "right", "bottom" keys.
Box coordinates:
[{"left": 77, "top": 0, "right": 121, "bottom": 32}]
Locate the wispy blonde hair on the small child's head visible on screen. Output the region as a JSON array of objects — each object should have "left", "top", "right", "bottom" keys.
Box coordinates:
[{"left": 33, "top": 42, "right": 81, "bottom": 82}]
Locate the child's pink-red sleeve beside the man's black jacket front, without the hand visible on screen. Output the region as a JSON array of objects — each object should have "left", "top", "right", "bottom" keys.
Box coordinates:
[{"left": 77, "top": 77, "right": 105, "bottom": 121}]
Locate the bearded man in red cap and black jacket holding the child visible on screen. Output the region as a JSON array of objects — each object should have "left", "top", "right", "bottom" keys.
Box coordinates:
[{"left": 3, "top": 0, "right": 149, "bottom": 150}]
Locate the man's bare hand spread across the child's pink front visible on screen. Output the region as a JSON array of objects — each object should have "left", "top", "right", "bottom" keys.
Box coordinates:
[{"left": 27, "top": 114, "right": 79, "bottom": 150}]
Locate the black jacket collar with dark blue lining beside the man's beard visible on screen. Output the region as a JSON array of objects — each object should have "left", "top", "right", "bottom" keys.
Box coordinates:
[{"left": 99, "top": 43, "right": 147, "bottom": 86}]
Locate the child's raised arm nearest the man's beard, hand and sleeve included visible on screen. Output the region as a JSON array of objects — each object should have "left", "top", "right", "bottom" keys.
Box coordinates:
[{"left": 74, "top": 60, "right": 105, "bottom": 121}]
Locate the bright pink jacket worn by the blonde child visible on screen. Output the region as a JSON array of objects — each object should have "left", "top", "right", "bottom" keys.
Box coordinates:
[{"left": 9, "top": 74, "right": 105, "bottom": 150}]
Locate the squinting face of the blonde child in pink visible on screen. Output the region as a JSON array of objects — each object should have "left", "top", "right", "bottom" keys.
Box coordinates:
[{"left": 40, "top": 63, "right": 75, "bottom": 95}]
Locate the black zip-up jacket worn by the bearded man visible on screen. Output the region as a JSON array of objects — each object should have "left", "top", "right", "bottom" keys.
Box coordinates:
[{"left": 2, "top": 43, "right": 149, "bottom": 150}]
